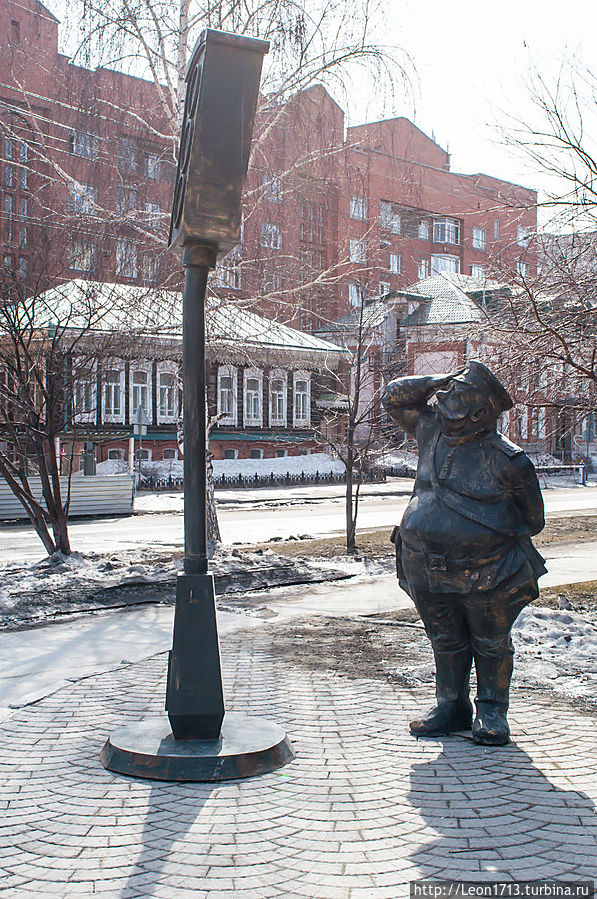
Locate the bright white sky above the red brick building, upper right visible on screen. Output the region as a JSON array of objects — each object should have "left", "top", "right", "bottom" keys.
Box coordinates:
[{"left": 355, "top": 0, "right": 597, "bottom": 196}]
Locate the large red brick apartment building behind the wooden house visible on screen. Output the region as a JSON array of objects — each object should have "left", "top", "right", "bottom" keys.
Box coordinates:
[{"left": 0, "top": 0, "right": 536, "bottom": 331}]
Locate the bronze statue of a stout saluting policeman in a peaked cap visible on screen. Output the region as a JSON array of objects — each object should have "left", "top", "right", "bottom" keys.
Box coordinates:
[{"left": 384, "top": 362, "right": 546, "bottom": 745}]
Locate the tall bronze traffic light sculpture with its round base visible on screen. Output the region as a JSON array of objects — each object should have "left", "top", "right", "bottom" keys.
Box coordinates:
[{"left": 102, "top": 29, "right": 294, "bottom": 781}]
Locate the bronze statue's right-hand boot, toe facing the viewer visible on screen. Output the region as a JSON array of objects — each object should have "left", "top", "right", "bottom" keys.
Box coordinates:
[{"left": 473, "top": 650, "right": 513, "bottom": 746}]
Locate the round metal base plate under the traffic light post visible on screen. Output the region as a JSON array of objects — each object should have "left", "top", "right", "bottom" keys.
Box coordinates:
[{"left": 100, "top": 712, "right": 294, "bottom": 781}]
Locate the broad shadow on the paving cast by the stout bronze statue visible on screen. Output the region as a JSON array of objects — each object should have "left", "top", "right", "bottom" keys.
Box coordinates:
[{"left": 408, "top": 737, "right": 597, "bottom": 881}]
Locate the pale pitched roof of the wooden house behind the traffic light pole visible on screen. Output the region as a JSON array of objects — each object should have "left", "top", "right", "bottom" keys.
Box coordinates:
[{"left": 37, "top": 278, "right": 346, "bottom": 358}]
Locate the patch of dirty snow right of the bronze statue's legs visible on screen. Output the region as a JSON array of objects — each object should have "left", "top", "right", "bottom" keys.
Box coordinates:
[{"left": 512, "top": 605, "right": 597, "bottom": 699}]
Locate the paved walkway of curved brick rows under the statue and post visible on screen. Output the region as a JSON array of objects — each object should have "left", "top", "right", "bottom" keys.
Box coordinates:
[{"left": 0, "top": 628, "right": 597, "bottom": 899}]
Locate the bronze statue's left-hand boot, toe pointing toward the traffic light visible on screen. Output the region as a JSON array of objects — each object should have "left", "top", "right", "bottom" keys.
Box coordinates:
[{"left": 409, "top": 650, "right": 473, "bottom": 737}]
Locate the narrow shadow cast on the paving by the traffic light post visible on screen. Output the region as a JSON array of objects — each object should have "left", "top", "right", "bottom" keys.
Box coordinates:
[{"left": 119, "top": 778, "right": 214, "bottom": 899}]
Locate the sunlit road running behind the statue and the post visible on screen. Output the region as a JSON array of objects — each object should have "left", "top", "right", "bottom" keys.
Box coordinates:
[{"left": 0, "top": 482, "right": 597, "bottom": 562}]
